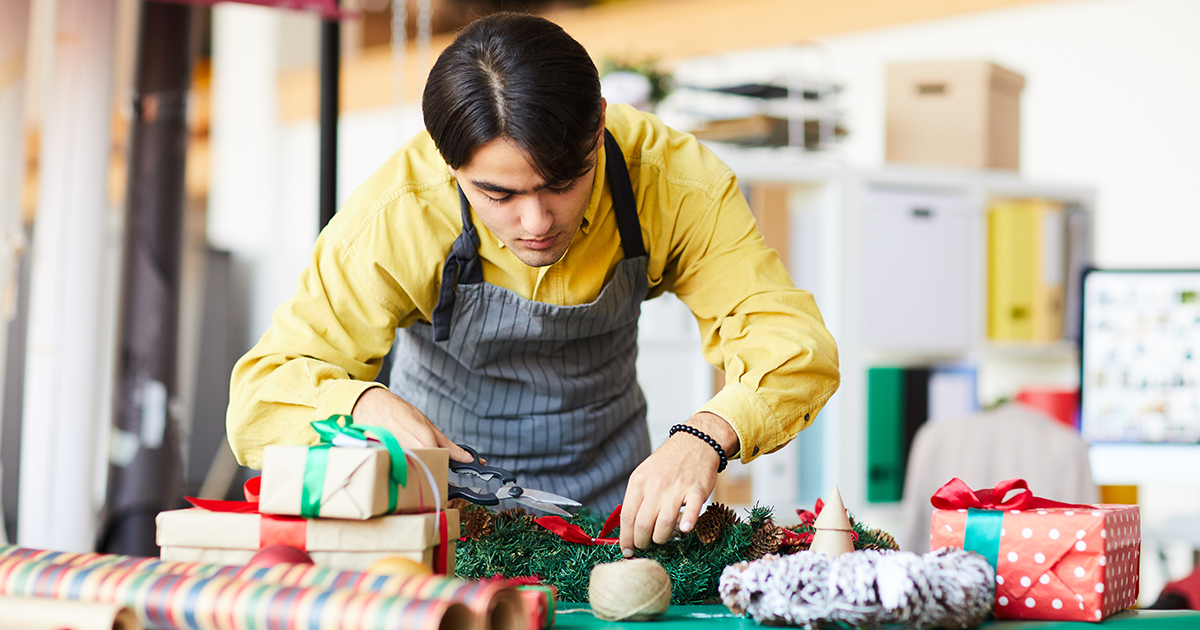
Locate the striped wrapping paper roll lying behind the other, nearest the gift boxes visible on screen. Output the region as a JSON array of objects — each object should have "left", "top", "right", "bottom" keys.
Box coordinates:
[{"left": 0, "top": 546, "right": 529, "bottom": 630}]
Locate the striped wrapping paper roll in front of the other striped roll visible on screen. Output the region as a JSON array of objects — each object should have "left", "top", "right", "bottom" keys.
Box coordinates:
[{"left": 0, "top": 558, "right": 479, "bottom": 630}]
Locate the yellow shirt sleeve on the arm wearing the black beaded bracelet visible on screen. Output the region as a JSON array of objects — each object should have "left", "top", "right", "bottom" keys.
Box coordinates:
[{"left": 665, "top": 162, "right": 839, "bottom": 462}]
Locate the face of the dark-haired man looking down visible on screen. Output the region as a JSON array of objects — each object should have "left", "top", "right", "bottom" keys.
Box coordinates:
[{"left": 451, "top": 137, "right": 596, "bottom": 266}]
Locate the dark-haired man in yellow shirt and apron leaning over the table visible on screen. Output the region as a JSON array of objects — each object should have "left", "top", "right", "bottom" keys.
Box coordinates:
[{"left": 228, "top": 13, "right": 839, "bottom": 556}]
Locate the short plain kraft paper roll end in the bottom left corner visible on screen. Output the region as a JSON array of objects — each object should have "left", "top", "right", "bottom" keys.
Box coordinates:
[{"left": 0, "top": 596, "right": 143, "bottom": 630}]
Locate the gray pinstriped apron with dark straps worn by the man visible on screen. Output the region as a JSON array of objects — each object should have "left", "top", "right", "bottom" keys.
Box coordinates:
[{"left": 390, "top": 130, "right": 650, "bottom": 514}]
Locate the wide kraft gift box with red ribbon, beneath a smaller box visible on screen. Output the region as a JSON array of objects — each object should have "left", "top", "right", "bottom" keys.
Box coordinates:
[{"left": 156, "top": 502, "right": 460, "bottom": 575}]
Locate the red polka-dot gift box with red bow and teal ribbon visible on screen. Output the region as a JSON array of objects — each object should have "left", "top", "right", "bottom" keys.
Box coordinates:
[{"left": 930, "top": 479, "right": 1141, "bottom": 622}]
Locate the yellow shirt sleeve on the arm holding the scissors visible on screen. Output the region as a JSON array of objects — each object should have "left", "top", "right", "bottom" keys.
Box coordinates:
[{"left": 226, "top": 191, "right": 457, "bottom": 468}]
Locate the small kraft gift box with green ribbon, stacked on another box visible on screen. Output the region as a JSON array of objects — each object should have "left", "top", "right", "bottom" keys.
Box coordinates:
[{"left": 258, "top": 445, "right": 450, "bottom": 520}]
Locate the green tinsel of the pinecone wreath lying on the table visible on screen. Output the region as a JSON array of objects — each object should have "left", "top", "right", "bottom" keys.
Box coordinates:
[{"left": 455, "top": 504, "right": 896, "bottom": 604}]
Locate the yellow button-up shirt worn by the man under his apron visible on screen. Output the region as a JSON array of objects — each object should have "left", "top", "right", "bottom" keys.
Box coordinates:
[{"left": 227, "top": 104, "right": 839, "bottom": 468}]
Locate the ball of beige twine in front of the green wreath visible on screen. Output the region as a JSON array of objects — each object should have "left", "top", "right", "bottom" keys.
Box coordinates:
[{"left": 588, "top": 558, "right": 671, "bottom": 622}]
